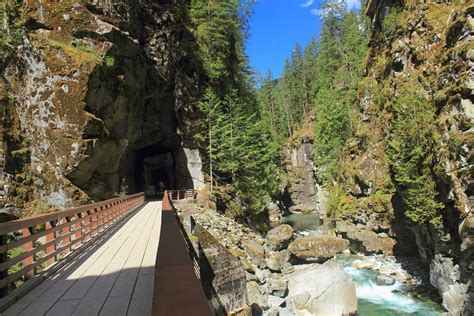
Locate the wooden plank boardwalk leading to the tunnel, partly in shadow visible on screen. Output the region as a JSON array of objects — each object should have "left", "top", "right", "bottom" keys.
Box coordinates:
[{"left": 2, "top": 202, "right": 162, "bottom": 316}]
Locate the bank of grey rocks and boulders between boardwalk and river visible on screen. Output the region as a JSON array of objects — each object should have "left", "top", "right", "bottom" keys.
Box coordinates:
[{"left": 180, "top": 209, "right": 357, "bottom": 315}]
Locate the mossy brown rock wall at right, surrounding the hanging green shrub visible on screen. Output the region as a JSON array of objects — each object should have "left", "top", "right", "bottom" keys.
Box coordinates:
[{"left": 340, "top": 0, "right": 474, "bottom": 315}]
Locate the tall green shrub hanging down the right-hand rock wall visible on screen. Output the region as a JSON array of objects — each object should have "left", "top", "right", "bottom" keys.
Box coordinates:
[{"left": 387, "top": 86, "right": 442, "bottom": 224}]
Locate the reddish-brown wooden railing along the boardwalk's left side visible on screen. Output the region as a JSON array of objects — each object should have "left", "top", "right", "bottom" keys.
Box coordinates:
[{"left": 0, "top": 193, "right": 145, "bottom": 306}]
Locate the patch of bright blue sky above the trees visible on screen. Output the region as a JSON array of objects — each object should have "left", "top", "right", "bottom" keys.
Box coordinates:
[{"left": 247, "top": 0, "right": 359, "bottom": 78}]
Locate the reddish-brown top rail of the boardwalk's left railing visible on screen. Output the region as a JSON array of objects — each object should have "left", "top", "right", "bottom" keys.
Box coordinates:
[{"left": 0, "top": 193, "right": 144, "bottom": 235}]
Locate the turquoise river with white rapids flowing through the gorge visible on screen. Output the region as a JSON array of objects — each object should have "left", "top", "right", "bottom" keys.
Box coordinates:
[{"left": 283, "top": 214, "right": 445, "bottom": 316}]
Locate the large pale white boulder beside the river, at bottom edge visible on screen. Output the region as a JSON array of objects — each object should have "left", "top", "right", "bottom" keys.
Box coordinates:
[{"left": 288, "top": 260, "right": 357, "bottom": 316}]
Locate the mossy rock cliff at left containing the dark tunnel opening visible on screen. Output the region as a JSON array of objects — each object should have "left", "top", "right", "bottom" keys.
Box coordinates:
[{"left": 0, "top": 0, "right": 203, "bottom": 208}]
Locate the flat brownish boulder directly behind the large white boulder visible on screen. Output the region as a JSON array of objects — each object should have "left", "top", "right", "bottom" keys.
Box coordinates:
[{"left": 288, "top": 235, "right": 349, "bottom": 261}]
